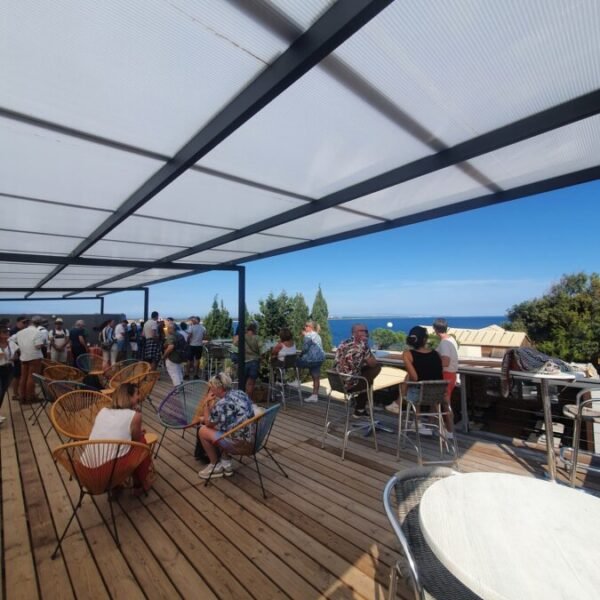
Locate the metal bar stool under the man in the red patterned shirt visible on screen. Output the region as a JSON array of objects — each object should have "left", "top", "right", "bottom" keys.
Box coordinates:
[{"left": 321, "top": 371, "right": 378, "bottom": 460}]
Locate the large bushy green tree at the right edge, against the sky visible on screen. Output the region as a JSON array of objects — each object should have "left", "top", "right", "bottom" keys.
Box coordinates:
[{"left": 505, "top": 273, "right": 600, "bottom": 364}]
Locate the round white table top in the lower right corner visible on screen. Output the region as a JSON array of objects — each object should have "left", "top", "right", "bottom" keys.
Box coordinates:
[{"left": 419, "top": 473, "right": 600, "bottom": 600}]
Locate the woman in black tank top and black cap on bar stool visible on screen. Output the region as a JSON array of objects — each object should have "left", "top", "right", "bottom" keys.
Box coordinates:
[{"left": 385, "top": 326, "right": 443, "bottom": 435}]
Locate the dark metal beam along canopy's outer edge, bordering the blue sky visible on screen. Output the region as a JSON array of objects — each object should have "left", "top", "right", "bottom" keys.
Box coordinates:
[{"left": 237, "top": 166, "right": 600, "bottom": 264}]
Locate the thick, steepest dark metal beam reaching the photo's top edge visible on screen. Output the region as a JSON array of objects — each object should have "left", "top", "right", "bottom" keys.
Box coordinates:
[{"left": 32, "top": 0, "right": 392, "bottom": 293}]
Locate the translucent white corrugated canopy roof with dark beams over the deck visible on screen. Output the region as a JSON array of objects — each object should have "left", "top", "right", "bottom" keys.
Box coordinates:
[{"left": 0, "top": 0, "right": 600, "bottom": 298}]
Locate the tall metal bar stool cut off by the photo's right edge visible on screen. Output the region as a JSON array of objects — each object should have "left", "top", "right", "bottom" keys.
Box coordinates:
[{"left": 560, "top": 388, "right": 600, "bottom": 487}]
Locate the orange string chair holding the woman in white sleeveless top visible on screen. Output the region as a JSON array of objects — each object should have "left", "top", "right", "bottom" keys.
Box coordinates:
[{"left": 52, "top": 440, "right": 151, "bottom": 559}]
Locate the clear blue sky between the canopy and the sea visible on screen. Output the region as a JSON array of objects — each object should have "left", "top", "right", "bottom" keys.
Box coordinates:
[{"left": 1, "top": 182, "right": 600, "bottom": 318}]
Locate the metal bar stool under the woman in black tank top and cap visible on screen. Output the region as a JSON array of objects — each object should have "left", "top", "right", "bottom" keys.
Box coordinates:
[{"left": 396, "top": 380, "right": 458, "bottom": 466}]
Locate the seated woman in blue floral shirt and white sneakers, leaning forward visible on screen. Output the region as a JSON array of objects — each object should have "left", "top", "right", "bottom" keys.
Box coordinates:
[{"left": 198, "top": 373, "right": 254, "bottom": 479}]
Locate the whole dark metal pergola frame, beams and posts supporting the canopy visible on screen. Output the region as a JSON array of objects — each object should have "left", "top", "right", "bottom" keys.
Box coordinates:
[{"left": 0, "top": 0, "right": 600, "bottom": 381}]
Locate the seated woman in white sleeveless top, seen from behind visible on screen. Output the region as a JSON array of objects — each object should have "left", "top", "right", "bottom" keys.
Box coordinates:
[{"left": 88, "top": 383, "right": 153, "bottom": 496}]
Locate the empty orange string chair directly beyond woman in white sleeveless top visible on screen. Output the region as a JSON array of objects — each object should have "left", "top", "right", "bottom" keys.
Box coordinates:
[{"left": 50, "top": 390, "right": 112, "bottom": 440}]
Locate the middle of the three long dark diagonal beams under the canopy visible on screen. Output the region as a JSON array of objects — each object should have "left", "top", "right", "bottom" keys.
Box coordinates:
[{"left": 151, "top": 90, "right": 600, "bottom": 263}]
